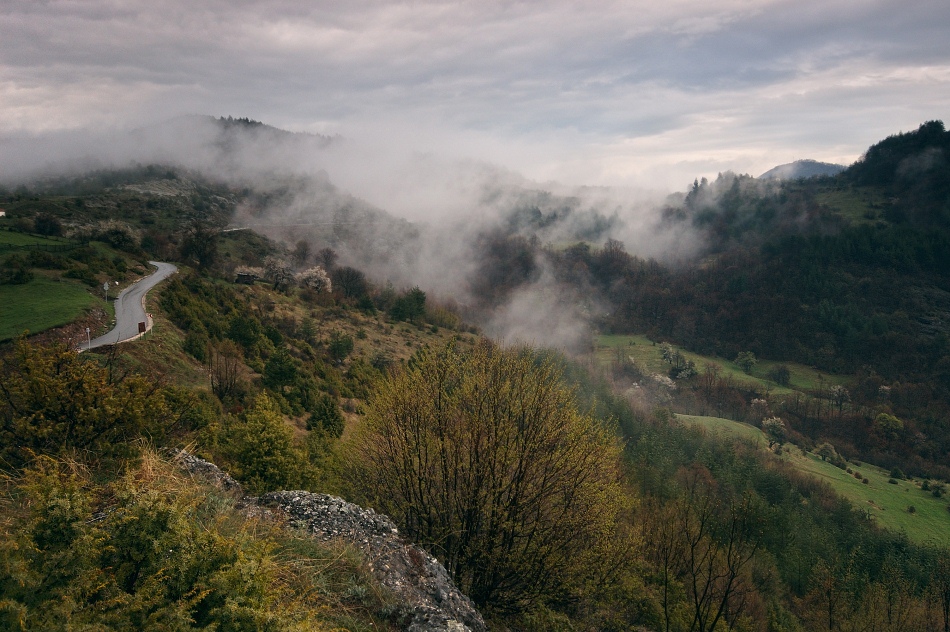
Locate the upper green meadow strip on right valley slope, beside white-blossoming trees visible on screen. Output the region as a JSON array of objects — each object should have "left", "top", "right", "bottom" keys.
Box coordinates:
[{"left": 596, "top": 335, "right": 849, "bottom": 395}]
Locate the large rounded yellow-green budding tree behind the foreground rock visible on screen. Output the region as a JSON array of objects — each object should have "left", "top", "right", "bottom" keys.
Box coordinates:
[{"left": 351, "top": 342, "right": 624, "bottom": 611}]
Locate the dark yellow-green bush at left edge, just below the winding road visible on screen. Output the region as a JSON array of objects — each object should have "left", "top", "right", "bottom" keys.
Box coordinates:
[{"left": 0, "top": 340, "right": 168, "bottom": 467}]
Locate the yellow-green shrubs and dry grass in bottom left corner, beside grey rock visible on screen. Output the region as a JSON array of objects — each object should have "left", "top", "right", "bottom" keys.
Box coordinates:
[{"left": 0, "top": 452, "right": 360, "bottom": 632}]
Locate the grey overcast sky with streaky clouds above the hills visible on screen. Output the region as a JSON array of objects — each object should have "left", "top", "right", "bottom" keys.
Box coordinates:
[{"left": 0, "top": 0, "right": 950, "bottom": 190}]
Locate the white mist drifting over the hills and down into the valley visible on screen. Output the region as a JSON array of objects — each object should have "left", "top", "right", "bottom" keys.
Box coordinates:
[{"left": 0, "top": 116, "right": 702, "bottom": 350}]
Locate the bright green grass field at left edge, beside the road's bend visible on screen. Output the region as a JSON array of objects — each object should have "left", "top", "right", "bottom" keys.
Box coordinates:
[{"left": 0, "top": 274, "right": 102, "bottom": 340}]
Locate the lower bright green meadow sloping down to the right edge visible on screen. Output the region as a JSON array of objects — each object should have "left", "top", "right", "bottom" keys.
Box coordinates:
[{"left": 676, "top": 415, "right": 950, "bottom": 546}]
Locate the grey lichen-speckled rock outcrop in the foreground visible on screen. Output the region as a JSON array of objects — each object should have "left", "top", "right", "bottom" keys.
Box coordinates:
[{"left": 175, "top": 451, "right": 488, "bottom": 632}]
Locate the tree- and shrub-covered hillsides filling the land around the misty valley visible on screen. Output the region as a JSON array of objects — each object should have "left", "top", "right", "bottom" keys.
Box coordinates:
[{"left": 0, "top": 120, "right": 950, "bottom": 632}]
